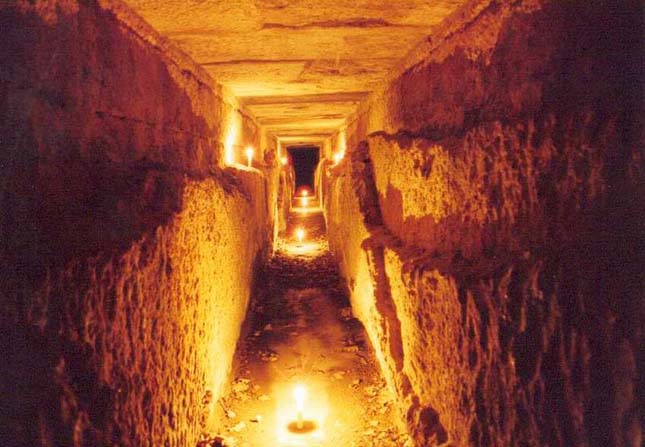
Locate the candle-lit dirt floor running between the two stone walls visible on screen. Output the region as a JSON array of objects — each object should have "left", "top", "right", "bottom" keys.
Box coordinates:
[{"left": 204, "top": 201, "right": 411, "bottom": 447}]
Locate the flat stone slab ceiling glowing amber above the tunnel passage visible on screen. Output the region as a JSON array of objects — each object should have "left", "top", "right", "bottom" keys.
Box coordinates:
[{"left": 126, "top": 0, "right": 464, "bottom": 141}]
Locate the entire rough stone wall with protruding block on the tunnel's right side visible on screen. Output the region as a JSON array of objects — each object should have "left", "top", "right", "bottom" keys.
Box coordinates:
[{"left": 326, "top": 1, "right": 645, "bottom": 446}]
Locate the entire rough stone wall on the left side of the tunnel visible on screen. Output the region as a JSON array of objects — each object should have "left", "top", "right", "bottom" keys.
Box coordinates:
[{"left": 0, "top": 0, "right": 271, "bottom": 447}]
